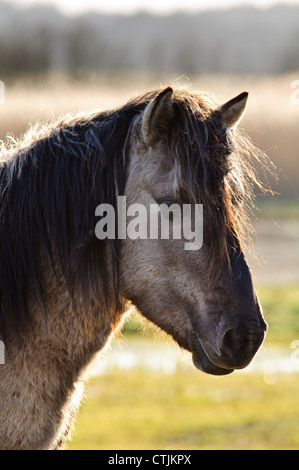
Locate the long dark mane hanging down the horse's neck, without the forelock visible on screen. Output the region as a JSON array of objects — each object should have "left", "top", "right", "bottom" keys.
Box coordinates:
[{"left": 0, "top": 97, "right": 144, "bottom": 340}]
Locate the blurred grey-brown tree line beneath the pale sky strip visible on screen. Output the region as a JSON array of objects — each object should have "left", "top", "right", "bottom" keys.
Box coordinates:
[{"left": 0, "top": 3, "right": 299, "bottom": 80}]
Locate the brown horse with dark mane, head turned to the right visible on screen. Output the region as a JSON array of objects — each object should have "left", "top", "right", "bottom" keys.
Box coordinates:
[{"left": 0, "top": 86, "right": 267, "bottom": 450}]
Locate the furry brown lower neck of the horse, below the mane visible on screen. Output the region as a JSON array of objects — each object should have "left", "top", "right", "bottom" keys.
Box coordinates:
[{"left": 0, "top": 266, "right": 116, "bottom": 449}]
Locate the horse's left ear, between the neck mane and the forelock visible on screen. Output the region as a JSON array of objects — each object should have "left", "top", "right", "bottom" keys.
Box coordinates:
[{"left": 142, "top": 87, "right": 175, "bottom": 144}]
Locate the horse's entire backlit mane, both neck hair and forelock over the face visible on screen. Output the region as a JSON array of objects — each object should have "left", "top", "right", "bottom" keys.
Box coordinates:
[{"left": 0, "top": 85, "right": 274, "bottom": 337}]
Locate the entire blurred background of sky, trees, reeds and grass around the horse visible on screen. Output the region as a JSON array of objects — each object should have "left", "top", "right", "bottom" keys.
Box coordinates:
[{"left": 0, "top": 0, "right": 299, "bottom": 449}]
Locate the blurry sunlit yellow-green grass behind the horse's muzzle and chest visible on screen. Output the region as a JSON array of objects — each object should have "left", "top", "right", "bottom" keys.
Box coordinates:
[{"left": 69, "top": 286, "right": 299, "bottom": 450}]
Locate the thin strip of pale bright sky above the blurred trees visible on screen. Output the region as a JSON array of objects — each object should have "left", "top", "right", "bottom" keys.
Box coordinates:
[{"left": 9, "top": 0, "right": 299, "bottom": 15}]
